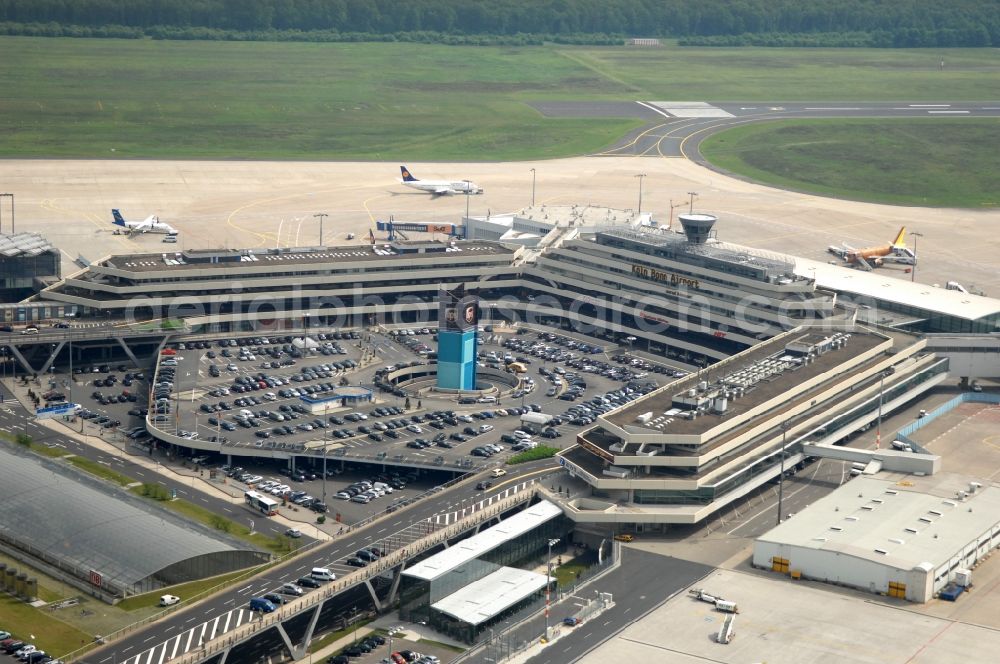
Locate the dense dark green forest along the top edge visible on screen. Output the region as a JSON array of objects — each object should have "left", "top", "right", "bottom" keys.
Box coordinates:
[{"left": 0, "top": 0, "right": 1000, "bottom": 48}]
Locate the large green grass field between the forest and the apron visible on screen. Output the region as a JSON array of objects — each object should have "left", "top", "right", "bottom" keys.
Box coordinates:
[{"left": 0, "top": 37, "right": 1000, "bottom": 161}]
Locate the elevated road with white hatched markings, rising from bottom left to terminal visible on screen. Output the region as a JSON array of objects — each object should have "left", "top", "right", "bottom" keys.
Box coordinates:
[{"left": 80, "top": 459, "right": 556, "bottom": 664}]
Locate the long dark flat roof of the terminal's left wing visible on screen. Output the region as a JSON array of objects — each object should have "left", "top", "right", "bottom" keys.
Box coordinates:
[{"left": 100, "top": 240, "right": 517, "bottom": 272}]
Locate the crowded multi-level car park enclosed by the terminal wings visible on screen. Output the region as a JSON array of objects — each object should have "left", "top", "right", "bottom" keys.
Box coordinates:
[{"left": 39, "top": 328, "right": 674, "bottom": 524}]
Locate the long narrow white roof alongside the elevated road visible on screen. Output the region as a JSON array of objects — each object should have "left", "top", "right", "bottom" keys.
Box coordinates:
[{"left": 403, "top": 500, "right": 562, "bottom": 581}]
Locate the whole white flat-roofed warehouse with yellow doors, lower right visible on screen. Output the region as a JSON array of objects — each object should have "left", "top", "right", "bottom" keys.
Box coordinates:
[{"left": 753, "top": 473, "right": 1000, "bottom": 602}]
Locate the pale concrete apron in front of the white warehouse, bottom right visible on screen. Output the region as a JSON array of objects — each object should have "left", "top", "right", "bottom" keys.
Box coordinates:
[{"left": 577, "top": 564, "right": 1000, "bottom": 664}]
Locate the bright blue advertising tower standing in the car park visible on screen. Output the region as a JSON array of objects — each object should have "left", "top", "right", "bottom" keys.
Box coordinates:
[{"left": 437, "top": 287, "right": 479, "bottom": 390}]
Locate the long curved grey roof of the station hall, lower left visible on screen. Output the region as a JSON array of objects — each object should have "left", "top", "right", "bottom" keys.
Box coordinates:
[{"left": 0, "top": 449, "right": 270, "bottom": 601}]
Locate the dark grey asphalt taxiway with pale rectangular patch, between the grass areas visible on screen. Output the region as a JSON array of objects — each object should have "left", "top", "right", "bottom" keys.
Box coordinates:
[{"left": 532, "top": 101, "right": 1000, "bottom": 159}]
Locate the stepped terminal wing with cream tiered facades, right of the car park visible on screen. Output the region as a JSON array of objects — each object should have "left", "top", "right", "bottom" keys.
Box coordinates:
[{"left": 559, "top": 326, "right": 948, "bottom": 531}]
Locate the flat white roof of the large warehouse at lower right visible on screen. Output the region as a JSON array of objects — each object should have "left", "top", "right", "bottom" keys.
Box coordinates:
[{"left": 758, "top": 473, "right": 1000, "bottom": 569}]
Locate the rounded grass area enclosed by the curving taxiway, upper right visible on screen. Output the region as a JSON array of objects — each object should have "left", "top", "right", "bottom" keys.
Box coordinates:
[{"left": 701, "top": 118, "right": 1000, "bottom": 207}]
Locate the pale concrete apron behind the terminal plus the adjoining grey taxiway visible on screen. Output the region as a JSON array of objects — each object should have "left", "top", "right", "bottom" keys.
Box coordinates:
[{"left": 0, "top": 101, "right": 1000, "bottom": 296}]
